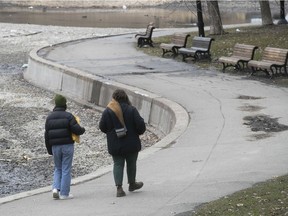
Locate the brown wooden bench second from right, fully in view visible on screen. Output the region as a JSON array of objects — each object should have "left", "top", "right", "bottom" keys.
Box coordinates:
[{"left": 218, "top": 43, "right": 258, "bottom": 72}]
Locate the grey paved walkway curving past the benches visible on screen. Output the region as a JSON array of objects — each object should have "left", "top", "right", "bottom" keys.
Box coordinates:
[{"left": 0, "top": 26, "right": 288, "bottom": 216}]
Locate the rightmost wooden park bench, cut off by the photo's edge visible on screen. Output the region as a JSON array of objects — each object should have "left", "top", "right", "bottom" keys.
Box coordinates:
[{"left": 248, "top": 47, "right": 288, "bottom": 78}]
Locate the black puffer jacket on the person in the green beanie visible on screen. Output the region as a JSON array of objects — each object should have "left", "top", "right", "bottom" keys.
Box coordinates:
[{"left": 45, "top": 107, "right": 85, "bottom": 155}]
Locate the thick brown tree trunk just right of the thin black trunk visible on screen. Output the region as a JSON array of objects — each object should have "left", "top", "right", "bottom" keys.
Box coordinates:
[{"left": 207, "top": 1, "right": 224, "bottom": 35}]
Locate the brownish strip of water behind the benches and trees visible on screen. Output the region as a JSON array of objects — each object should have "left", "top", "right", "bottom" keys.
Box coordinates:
[{"left": 0, "top": 7, "right": 261, "bottom": 28}]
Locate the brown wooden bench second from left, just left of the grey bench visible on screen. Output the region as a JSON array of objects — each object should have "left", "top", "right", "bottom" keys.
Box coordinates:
[{"left": 160, "top": 34, "right": 190, "bottom": 58}]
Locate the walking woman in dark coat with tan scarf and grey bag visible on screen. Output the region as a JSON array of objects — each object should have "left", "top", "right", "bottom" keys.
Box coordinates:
[{"left": 99, "top": 89, "right": 146, "bottom": 197}]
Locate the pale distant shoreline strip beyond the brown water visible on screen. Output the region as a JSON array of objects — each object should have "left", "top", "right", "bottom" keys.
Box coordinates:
[{"left": 0, "top": 0, "right": 282, "bottom": 12}]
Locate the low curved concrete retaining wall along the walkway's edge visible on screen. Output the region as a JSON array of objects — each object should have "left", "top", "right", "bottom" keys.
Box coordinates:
[{"left": 24, "top": 39, "right": 189, "bottom": 147}]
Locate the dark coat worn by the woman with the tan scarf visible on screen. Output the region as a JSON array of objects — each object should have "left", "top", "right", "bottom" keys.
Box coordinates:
[{"left": 99, "top": 103, "right": 146, "bottom": 155}]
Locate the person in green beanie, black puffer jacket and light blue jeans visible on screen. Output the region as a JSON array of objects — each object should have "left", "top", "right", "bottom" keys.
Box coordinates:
[{"left": 45, "top": 95, "right": 85, "bottom": 199}]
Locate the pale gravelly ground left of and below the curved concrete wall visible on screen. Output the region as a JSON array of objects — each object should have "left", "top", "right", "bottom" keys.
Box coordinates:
[{"left": 0, "top": 23, "right": 160, "bottom": 197}]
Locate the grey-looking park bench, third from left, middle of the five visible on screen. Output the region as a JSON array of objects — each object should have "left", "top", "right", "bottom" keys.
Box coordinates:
[{"left": 178, "top": 36, "right": 214, "bottom": 61}]
